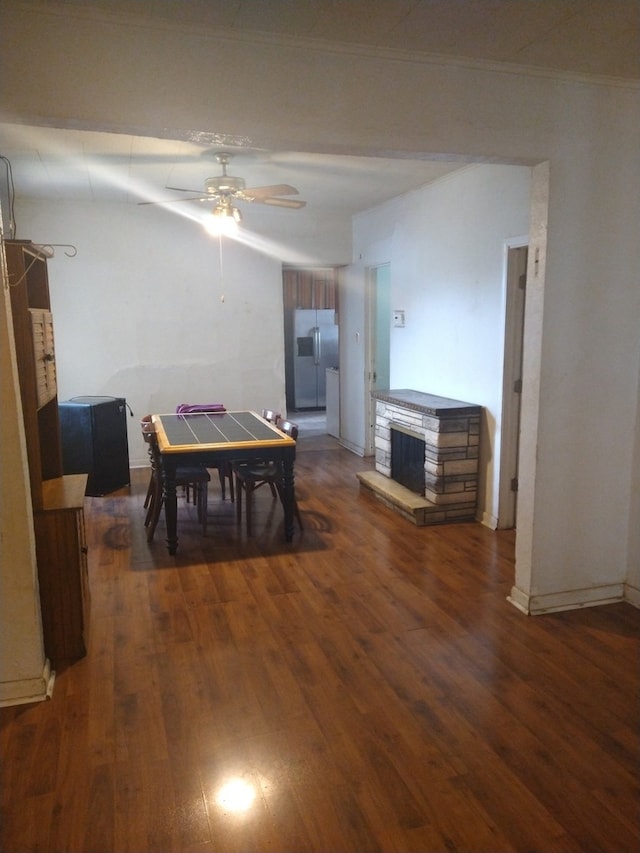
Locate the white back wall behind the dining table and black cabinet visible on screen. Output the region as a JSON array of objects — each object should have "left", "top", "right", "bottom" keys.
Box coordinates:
[{"left": 16, "top": 201, "right": 338, "bottom": 465}]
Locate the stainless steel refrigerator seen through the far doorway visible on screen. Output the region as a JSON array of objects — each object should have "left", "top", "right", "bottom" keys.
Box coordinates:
[{"left": 293, "top": 308, "right": 338, "bottom": 409}]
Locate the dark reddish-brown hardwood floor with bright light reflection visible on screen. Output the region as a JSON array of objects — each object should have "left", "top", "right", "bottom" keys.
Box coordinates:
[{"left": 0, "top": 438, "right": 640, "bottom": 853}]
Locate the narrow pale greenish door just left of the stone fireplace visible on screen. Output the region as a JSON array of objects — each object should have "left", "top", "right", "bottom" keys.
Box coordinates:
[{"left": 365, "top": 264, "right": 391, "bottom": 456}]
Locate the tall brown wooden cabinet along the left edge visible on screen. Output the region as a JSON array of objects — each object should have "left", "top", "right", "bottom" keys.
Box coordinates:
[{"left": 5, "top": 240, "right": 89, "bottom": 663}]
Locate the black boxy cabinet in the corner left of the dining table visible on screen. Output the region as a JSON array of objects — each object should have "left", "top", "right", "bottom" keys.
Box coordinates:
[{"left": 59, "top": 397, "right": 131, "bottom": 496}]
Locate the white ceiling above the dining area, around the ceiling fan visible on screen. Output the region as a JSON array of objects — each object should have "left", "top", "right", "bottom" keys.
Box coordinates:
[{"left": 0, "top": 124, "right": 460, "bottom": 214}]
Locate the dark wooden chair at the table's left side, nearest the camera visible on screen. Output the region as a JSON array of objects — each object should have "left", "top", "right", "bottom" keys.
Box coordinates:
[{"left": 141, "top": 416, "right": 211, "bottom": 542}]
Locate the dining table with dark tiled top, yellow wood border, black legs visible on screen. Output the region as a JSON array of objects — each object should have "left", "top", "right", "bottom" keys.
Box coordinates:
[{"left": 151, "top": 410, "right": 296, "bottom": 555}]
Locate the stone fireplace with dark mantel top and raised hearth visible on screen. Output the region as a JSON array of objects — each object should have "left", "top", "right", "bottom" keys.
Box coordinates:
[{"left": 358, "top": 389, "right": 481, "bottom": 525}]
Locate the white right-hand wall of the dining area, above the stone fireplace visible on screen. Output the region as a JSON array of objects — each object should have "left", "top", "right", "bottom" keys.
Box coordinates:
[{"left": 342, "top": 165, "right": 531, "bottom": 526}]
